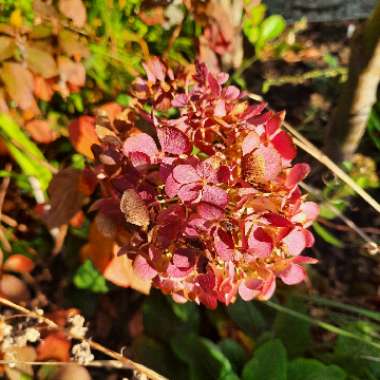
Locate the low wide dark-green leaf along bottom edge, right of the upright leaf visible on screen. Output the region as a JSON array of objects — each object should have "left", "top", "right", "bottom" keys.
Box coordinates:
[{"left": 288, "top": 358, "right": 347, "bottom": 380}]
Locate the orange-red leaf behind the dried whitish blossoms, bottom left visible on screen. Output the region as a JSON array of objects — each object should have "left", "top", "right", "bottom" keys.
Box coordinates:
[{"left": 37, "top": 332, "right": 71, "bottom": 362}]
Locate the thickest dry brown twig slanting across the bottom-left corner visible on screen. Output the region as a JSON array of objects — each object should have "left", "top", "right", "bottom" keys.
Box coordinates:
[{"left": 0, "top": 296, "right": 167, "bottom": 380}]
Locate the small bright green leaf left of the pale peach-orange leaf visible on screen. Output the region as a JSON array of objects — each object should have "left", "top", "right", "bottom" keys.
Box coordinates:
[{"left": 73, "top": 260, "right": 109, "bottom": 293}]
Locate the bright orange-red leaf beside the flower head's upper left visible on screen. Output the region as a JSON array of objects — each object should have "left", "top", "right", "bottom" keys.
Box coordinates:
[{"left": 69, "top": 116, "right": 99, "bottom": 159}]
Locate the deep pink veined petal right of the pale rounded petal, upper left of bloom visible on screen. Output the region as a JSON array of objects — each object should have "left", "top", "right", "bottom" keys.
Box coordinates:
[{"left": 157, "top": 127, "right": 191, "bottom": 155}]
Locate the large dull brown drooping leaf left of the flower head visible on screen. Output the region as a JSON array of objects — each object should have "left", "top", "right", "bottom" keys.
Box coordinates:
[{"left": 45, "top": 168, "right": 84, "bottom": 228}]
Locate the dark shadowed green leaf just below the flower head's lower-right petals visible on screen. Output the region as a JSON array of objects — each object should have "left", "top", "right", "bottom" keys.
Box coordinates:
[{"left": 227, "top": 298, "right": 267, "bottom": 336}]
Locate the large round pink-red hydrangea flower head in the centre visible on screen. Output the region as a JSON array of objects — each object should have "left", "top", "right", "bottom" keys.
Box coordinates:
[{"left": 92, "top": 59, "right": 318, "bottom": 308}]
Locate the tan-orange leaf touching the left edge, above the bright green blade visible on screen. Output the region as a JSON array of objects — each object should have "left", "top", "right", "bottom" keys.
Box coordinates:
[{"left": 0, "top": 62, "right": 39, "bottom": 115}]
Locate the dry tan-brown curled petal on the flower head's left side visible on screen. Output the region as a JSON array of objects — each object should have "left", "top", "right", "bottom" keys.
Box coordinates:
[{"left": 120, "top": 189, "right": 149, "bottom": 229}]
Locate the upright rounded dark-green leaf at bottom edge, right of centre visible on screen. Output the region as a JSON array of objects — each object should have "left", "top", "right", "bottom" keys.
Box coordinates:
[{"left": 242, "top": 339, "right": 286, "bottom": 380}]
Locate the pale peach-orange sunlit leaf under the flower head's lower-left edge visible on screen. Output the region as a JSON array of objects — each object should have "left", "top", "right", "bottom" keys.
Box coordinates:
[{"left": 103, "top": 248, "right": 151, "bottom": 294}]
